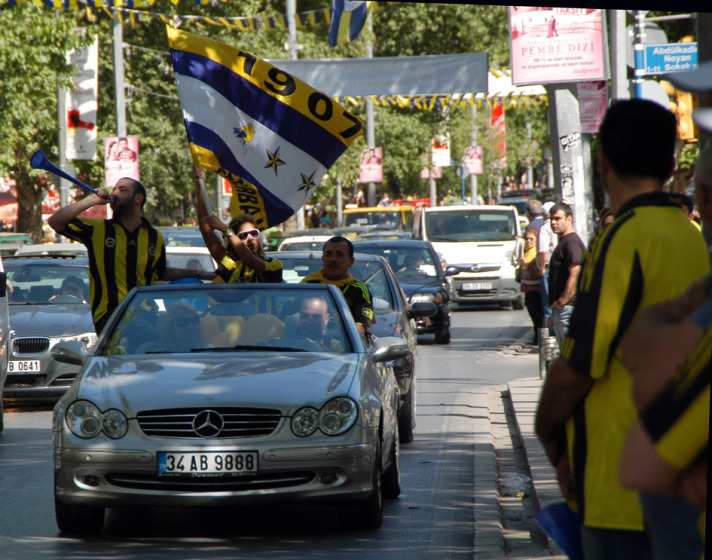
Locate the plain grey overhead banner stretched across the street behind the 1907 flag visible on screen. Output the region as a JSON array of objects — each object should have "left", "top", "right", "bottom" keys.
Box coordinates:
[{"left": 268, "top": 53, "right": 489, "bottom": 97}]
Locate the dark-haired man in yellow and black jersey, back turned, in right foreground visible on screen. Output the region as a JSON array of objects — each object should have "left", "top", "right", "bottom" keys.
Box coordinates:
[{"left": 535, "top": 99, "right": 710, "bottom": 560}]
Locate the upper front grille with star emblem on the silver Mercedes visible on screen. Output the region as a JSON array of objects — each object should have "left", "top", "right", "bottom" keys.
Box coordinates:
[{"left": 136, "top": 407, "right": 282, "bottom": 438}]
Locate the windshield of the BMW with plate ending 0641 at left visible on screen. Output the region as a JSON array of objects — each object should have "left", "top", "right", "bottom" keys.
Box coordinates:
[{"left": 5, "top": 260, "right": 89, "bottom": 305}]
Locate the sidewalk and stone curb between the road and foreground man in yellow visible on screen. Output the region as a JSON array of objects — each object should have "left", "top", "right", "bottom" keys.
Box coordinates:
[{"left": 473, "top": 370, "right": 567, "bottom": 560}]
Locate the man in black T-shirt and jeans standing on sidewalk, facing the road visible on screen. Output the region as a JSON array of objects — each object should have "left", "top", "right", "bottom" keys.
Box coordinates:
[{"left": 549, "top": 202, "right": 586, "bottom": 348}]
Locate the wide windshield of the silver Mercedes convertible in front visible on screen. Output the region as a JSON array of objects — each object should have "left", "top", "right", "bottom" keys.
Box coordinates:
[{"left": 100, "top": 284, "right": 352, "bottom": 356}]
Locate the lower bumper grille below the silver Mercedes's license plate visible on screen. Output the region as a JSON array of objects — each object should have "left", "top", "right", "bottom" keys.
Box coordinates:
[{"left": 106, "top": 471, "right": 314, "bottom": 493}]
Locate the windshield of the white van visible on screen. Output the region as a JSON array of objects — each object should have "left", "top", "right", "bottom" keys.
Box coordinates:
[{"left": 425, "top": 210, "right": 517, "bottom": 241}]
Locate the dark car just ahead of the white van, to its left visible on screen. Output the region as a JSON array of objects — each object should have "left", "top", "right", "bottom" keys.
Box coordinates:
[{"left": 354, "top": 239, "right": 459, "bottom": 344}]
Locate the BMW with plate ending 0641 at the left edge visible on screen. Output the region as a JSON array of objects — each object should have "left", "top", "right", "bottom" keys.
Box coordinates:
[{"left": 4, "top": 255, "right": 97, "bottom": 400}]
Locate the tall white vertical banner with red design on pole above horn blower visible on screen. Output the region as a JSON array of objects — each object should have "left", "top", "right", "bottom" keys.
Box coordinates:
[{"left": 64, "top": 29, "right": 99, "bottom": 159}]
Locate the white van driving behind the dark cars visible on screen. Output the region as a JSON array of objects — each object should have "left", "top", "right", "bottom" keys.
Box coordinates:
[{"left": 413, "top": 206, "right": 524, "bottom": 309}]
